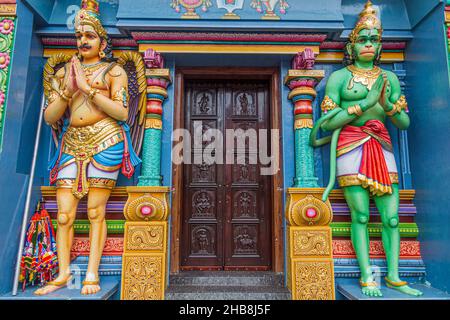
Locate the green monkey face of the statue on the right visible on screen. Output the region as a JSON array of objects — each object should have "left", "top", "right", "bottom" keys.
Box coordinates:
[{"left": 353, "top": 29, "right": 381, "bottom": 62}]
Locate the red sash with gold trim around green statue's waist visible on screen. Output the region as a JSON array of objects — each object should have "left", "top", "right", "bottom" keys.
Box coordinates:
[{"left": 337, "top": 120, "right": 392, "bottom": 195}]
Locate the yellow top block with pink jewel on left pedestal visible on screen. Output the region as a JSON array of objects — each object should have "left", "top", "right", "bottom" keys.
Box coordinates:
[{"left": 124, "top": 187, "right": 170, "bottom": 221}]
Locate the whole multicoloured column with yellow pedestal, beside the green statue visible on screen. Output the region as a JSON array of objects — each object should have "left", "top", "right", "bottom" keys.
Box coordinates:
[{"left": 285, "top": 49, "right": 335, "bottom": 300}]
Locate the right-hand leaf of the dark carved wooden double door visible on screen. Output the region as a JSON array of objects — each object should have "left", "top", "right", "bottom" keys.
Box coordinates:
[{"left": 224, "top": 81, "right": 271, "bottom": 269}]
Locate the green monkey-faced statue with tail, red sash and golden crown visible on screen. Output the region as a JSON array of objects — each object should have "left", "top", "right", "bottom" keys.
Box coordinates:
[{"left": 311, "top": 1, "right": 422, "bottom": 297}]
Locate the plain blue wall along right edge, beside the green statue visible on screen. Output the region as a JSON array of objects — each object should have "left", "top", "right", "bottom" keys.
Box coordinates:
[{"left": 405, "top": 1, "right": 450, "bottom": 292}]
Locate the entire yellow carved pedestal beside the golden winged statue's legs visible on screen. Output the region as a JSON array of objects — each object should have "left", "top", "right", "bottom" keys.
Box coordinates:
[{"left": 121, "top": 187, "right": 170, "bottom": 300}]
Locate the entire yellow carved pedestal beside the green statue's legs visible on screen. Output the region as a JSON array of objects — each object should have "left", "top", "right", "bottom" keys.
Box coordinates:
[{"left": 286, "top": 188, "right": 335, "bottom": 300}]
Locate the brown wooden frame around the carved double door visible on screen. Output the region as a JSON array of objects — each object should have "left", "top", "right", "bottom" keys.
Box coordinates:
[{"left": 170, "top": 67, "right": 284, "bottom": 274}]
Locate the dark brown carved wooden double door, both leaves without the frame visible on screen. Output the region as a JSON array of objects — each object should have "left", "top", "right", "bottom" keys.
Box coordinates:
[{"left": 180, "top": 80, "right": 272, "bottom": 270}]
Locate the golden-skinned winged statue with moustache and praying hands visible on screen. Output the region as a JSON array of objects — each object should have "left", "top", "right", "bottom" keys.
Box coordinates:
[{"left": 35, "top": 0, "right": 147, "bottom": 295}]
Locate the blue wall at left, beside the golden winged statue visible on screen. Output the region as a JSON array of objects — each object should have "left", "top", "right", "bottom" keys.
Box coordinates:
[{"left": 0, "top": 2, "right": 43, "bottom": 295}]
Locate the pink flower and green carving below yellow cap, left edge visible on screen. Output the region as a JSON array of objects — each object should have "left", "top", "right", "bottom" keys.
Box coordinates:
[{"left": 0, "top": 12, "right": 15, "bottom": 149}]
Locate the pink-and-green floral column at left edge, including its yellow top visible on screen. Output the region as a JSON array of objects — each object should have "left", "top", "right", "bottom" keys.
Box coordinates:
[{"left": 0, "top": 0, "right": 17, "bottom": 152}]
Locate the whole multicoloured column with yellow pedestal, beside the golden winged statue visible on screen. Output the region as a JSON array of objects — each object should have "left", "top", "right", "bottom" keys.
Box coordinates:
[{"left": 121, "top": 49, "right": 171, "bottom": 300}]
